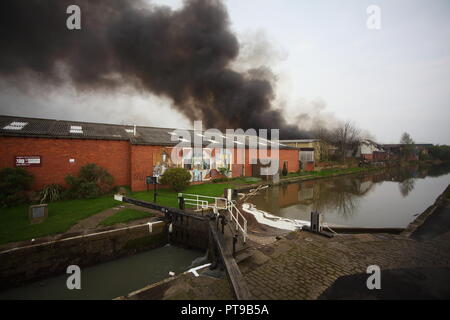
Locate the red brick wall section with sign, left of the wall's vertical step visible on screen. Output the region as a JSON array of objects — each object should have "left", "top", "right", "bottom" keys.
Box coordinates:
[{"left": 0, "top": 137, "right": 130, "bottom": 189}]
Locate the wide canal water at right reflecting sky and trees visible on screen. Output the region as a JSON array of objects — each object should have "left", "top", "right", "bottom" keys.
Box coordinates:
[{"left": 249, "top": 166, "right": 450, "bottom": 228}]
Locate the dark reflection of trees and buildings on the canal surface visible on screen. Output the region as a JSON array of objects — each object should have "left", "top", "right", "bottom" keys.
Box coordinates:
[{"left": 252, "top": 165, "right": 450, "bottom": 219}]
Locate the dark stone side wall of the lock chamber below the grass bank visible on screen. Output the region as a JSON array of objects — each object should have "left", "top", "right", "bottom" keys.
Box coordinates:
[{"left": 0, "top": 221, "right": 168, "bottom": 290}]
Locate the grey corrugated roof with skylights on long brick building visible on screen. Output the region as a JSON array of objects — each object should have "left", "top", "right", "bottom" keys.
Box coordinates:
[{"left": 0, "top": 115, "right": 296, "bottom": 149}]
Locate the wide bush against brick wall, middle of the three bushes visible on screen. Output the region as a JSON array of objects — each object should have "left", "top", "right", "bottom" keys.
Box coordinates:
[{"left": 66, "top": 163, "right": 114, "bottom": 199}]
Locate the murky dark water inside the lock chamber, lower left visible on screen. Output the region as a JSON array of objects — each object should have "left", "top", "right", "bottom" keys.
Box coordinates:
[{"left": 0, "top": 245, "right": 203, "bottom": 300}]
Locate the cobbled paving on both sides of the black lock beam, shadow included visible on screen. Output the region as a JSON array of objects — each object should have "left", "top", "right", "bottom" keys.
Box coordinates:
[{"left": 125, "top": 231, "right": 450, "bottom": 300}]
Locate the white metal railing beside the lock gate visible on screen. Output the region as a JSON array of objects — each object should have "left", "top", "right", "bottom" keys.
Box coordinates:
[{"left": 178, "top": 193, "right": 247, "bottom": 243}]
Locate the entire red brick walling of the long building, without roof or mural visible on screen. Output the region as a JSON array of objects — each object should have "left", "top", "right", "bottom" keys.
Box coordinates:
[{"left": 0, "top": 137, "right": 298, "bottom": 191}]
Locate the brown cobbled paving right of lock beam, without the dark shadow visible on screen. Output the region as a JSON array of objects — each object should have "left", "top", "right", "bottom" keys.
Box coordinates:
[{"left": 240, "top": 231, "right": 450, "bottom": 300}]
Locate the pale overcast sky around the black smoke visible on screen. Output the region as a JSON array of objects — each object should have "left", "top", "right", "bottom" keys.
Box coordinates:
[{"left": 0, "top": 0, "right": 450, "bottom": 144}]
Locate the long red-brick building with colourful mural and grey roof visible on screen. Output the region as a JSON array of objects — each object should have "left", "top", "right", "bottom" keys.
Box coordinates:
[{"left": 0, "top": 116, "right": 299, "bottom": 191}]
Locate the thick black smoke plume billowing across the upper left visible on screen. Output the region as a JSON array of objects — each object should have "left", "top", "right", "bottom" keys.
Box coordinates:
[{"left": 0, "top": 0, "right": 305, "bottom": 138}]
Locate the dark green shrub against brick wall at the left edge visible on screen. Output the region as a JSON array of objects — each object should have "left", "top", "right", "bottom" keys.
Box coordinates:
[{"left": 0, "top": 168, "right": 34, "bottom": 207}]
